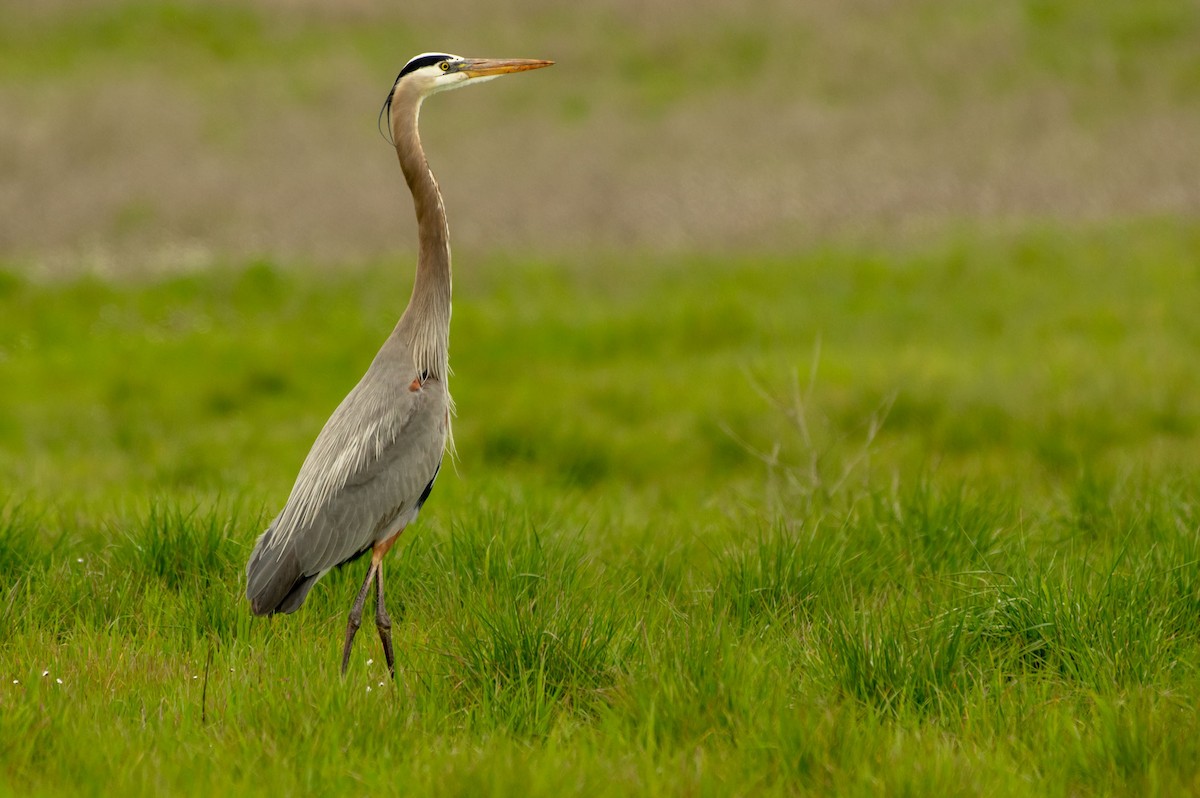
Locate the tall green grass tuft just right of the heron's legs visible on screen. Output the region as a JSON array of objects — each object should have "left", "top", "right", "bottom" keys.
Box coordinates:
[{"left": 433, "top": 522, "right": 634, "bottom": 734}]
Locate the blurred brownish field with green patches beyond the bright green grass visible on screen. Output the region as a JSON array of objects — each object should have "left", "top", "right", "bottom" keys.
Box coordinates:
[{"left": 0, "top": 0, "right": 1200, "bottom": 274}]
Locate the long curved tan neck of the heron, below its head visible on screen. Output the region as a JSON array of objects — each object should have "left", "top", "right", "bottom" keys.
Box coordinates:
[{"left": 391, "top": 84, "right": 451, "bottom": 380}]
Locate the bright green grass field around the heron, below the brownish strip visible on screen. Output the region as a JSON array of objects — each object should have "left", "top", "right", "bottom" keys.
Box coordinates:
[{"left": 0, "top": 221, "right": 1200, "bottom": 796}]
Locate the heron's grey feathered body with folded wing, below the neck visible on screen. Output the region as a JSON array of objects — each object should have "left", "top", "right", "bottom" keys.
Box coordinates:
[{"left": 246, "top": 364, "right": 450, "bottom": 614}]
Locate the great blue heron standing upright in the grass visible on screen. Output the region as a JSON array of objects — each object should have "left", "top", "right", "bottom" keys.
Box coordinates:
[{"left": 246, "top": 53, "right": 553, "bottom": 676}]
